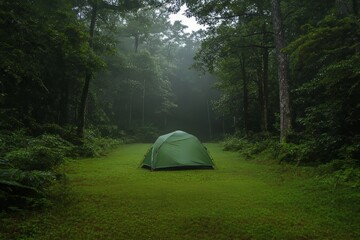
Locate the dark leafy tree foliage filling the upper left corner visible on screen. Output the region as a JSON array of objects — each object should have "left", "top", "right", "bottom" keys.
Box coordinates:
[{"left": 0, "top": 0, "right": 100, "bottom": 125}]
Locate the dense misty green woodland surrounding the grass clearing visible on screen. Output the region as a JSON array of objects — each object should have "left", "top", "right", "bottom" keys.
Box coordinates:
[{"left": 0, "top": 0, "right": 360, "bottom": 209}]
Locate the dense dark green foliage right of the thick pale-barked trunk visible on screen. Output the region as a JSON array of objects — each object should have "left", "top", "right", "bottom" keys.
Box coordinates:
[{"left": 288, "top": 16, "right": 360, "bottom": 162}]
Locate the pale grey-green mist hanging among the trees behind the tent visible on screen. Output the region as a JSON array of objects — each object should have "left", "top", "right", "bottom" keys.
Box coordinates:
[{"left": 70, "top": 4, "right": 229, "bottom": 140}]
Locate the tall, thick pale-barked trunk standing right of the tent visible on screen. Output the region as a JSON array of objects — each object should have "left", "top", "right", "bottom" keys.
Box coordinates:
[{"left": 271, "top": 0, "right": 291, "bottom": 143}]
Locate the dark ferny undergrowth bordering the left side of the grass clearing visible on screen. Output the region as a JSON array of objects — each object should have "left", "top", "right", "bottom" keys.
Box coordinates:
[{"left": 0, "top": 124, "right": 122, "bottom": 210}]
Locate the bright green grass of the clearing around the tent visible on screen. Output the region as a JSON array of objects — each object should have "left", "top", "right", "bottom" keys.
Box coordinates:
[{"left": 0, "top": 144, "right": 360, "bottom": 240}]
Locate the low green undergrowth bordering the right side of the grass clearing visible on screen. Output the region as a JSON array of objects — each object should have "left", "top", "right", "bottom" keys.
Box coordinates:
[{"left": 222, "top": 134, "right": 360, "bottom": 188}]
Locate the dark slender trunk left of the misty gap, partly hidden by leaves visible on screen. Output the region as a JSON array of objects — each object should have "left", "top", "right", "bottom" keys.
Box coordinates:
[{"left": 77, "top": 1, "right": 98, "bottom": 137}]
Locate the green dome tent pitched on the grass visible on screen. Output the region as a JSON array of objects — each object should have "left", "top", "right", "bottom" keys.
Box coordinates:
[{"left": 141, "top": 131, "right": 214, "bottom": 170}]
